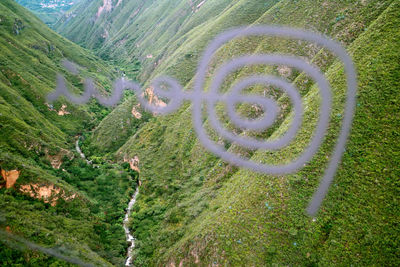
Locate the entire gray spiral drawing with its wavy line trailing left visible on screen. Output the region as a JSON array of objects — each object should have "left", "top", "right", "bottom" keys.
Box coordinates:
[{"left": 48, "top": 25, "right": 357, "bottom": 215}]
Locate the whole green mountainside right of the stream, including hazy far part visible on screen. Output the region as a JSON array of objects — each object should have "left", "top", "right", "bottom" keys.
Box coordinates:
[{"left": 34, "top": 0, "right": 400, "bottom": 266}]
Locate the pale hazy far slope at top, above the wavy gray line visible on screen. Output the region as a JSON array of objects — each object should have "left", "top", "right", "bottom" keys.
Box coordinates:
[{"left": 55, "top": 0, "right": 277, "bottom": 82}]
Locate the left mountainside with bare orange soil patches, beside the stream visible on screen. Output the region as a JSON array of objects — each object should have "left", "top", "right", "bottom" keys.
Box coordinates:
[{"left": 0, "top": 0, "right": 139, "bottom": 266}]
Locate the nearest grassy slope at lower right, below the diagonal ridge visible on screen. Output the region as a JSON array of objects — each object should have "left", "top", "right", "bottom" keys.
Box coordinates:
[{"left": 162, "top": 3, "right": 400, "bottom": 266}]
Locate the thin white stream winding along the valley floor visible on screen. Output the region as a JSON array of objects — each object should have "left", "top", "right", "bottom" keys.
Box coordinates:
[{"left": 75, "top": 137, "right": 139, "bottom": 266}]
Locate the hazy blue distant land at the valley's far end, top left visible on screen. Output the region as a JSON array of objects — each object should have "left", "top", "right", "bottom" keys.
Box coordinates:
[{"left": 16, "top": 0, "right": 78, "bottom": 26}]
